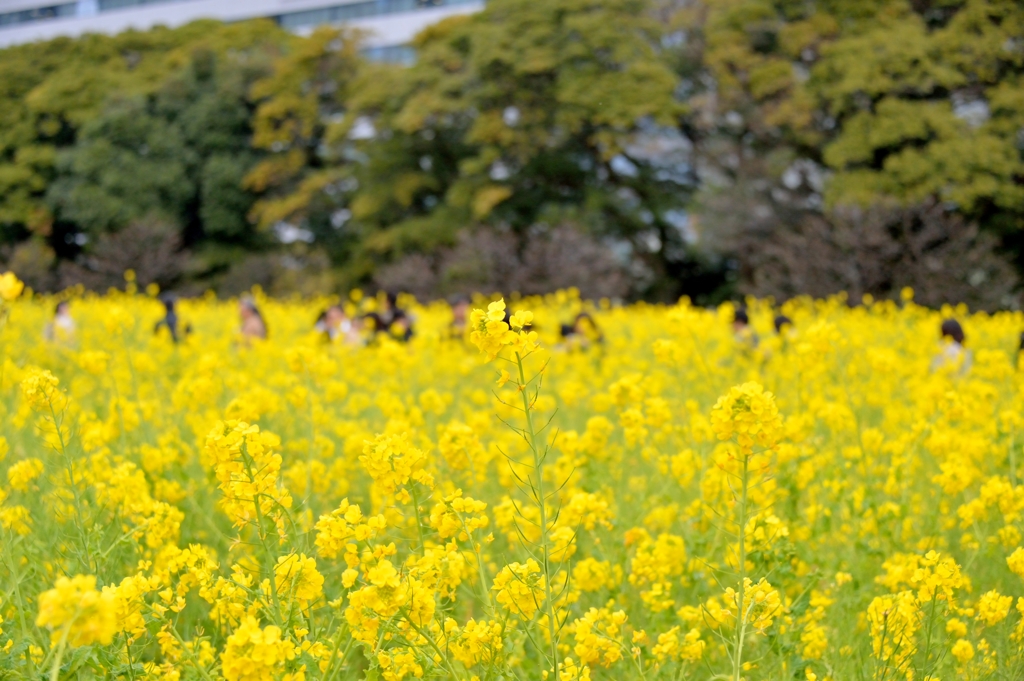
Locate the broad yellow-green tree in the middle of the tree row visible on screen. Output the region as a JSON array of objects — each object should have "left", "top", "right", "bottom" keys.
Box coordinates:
[{"left": 351, "top": 0, "right": 691, "bottom": 288}]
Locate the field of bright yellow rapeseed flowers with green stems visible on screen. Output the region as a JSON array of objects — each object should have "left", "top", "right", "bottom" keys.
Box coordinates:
[{"left": 0, "top": 272, "right": 1024, "bottom": 681}]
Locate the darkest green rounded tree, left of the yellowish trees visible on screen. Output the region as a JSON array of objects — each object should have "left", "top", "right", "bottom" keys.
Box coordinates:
[{"left": 47, "top": 40, "right": 284, "bottom": 273}]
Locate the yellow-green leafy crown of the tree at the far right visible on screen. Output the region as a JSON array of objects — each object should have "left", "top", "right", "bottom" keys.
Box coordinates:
[{"left": 689, "top": 0, "right": 1024, "bottom": 221}]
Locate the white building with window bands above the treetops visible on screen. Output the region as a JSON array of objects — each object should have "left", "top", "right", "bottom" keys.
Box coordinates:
[{"left": 0, "top": 0, "right": 483, "bottom": 55}]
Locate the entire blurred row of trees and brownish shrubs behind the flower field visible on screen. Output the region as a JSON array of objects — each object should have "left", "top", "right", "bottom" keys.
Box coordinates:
[{"left": 0, "top": 0, "right": 1024, "bottom": 308}]
